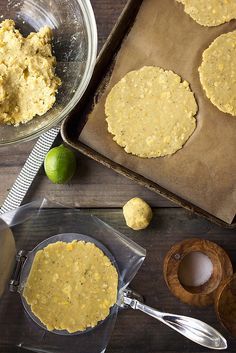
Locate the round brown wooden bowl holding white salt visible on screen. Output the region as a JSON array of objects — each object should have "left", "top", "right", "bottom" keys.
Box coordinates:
[{"left": 163, "top": 238, "right": 233, "bottom": 307}]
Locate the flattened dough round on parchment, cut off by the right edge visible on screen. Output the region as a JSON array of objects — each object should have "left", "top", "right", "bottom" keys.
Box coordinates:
[{"left": 198, "top": 31, "right": 236, "bottom": 116}]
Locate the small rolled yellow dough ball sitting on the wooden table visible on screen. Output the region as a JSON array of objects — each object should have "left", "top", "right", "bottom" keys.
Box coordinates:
[{"left": 123, "top": 197, "right": 152, "bottom": 230}]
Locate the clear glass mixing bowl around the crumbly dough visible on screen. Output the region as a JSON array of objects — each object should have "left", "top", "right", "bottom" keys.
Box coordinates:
[{"left": 0, "top": 0, "right": 97, "bottom": 145}]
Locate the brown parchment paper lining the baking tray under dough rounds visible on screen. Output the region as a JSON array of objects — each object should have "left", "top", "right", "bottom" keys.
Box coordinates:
[{"left": 80, "top": 0, "right": 236, "bottom": 223}]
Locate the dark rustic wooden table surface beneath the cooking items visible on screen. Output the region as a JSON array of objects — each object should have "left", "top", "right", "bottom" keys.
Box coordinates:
[{"left": 0, "top": 0, "right": 236, "bottom": 353}]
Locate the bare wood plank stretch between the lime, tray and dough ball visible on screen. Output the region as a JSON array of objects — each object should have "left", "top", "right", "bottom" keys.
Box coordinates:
[{"left": 29, "top": 151, "right": 176, "bottom": 208}]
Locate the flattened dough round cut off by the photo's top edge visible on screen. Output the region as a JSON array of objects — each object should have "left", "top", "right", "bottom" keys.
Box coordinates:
[{"left": 177, "top": 0, "right": 236, "bottom": 27}]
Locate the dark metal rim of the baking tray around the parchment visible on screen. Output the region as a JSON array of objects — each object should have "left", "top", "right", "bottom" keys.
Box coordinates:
[{"left": 61, "top": 0, "right": 236, "bottom": 228}]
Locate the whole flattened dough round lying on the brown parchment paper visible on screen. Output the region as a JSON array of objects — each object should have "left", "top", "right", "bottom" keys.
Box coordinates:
[{"left": 105, "top": 66, "right": 197, "bottom": 158}]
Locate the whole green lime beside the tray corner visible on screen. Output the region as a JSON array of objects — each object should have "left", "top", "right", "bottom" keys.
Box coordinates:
[{"left": 44, "top": 145, "right": 76, "bottom": 184}]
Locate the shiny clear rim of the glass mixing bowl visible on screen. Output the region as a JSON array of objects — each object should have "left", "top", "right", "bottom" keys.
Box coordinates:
[{"left": 0, "top": 0, "right": 98, "bottom": 147}]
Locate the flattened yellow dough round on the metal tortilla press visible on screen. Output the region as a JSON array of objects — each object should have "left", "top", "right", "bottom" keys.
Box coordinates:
[{"left": 23, "top": 241, "right": 118, "bottom": 333}]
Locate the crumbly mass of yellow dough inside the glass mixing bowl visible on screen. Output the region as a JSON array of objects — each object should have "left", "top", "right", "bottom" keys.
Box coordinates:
[{"left": 0, "top": 20, "right": 61, "bottom": 126}]
